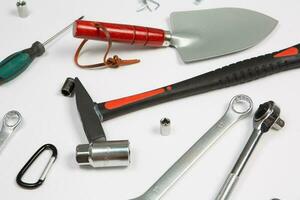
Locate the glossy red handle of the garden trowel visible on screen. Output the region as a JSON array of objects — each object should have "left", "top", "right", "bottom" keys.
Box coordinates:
[{"left": 73, "top": 20, "right": 165, "bottom": 47}]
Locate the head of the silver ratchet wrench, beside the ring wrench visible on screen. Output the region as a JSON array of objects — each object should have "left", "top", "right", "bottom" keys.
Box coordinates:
[{"left": 253, "top": 101, "right": 285, "bottom": 133}]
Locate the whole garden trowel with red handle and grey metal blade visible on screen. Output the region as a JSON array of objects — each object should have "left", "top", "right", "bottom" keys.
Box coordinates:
[{"left": 73, "top": 8, "right": 278, "bottom": 62}]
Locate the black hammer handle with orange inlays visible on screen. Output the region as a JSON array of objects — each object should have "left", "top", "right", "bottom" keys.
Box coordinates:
[{"left": 98, "top": 44, "right": 300, "bottom": 120}]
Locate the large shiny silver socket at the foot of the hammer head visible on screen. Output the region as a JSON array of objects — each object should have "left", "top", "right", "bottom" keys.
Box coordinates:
[{"left": 76, "top": 140, "right": 130, "bottom": 167}]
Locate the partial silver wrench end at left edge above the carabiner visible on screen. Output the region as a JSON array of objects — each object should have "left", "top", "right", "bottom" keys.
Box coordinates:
[{"left": 0, "top": 110, "right": 22, "bottom": 152}]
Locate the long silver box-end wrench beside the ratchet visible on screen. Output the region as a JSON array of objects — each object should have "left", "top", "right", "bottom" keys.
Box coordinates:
[{"left": 130, "top": 95, "right": 253, "bottom": 200}]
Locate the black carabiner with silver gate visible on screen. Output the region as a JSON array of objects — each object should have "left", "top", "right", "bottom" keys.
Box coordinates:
[{"left": 16, "top": 144, "right": 57, "bottom": 189}]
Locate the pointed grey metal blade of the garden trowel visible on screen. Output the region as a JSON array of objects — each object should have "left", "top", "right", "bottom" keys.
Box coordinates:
[{"left": 170, "top": 8, "right": 278, "bottom": 62}]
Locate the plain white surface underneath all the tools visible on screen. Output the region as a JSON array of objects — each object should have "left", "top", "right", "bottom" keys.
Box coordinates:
[{"left": 0, "top": 0, "right": 300, "bottom": 200}]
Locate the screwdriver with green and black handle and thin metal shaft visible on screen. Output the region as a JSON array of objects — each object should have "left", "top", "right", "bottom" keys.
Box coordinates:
[{"left": 0, "top": 16, "right": 83, "bottom": 85}]
